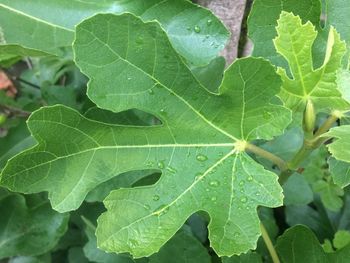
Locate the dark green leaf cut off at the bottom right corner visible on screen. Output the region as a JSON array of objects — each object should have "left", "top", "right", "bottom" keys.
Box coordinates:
[{"left": 276, "top": 225, "right": 350, "bottom": 263}]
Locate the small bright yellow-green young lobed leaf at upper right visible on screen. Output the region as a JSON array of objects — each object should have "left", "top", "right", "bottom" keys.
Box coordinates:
[{"left": 274, "top": 12, "right": 350, "bottom": 112}]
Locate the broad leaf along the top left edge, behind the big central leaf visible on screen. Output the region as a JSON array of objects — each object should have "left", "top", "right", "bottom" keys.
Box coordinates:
[{"left": 0, "top": 0, "right": 229, "bottom": 65}]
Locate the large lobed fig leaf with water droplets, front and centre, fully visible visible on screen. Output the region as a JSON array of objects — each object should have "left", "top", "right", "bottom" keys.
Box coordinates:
[{"left": 1, "top": 14, "right": 291, "bottom": 257}]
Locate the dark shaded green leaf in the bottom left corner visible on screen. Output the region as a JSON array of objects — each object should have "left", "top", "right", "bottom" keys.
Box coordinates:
[{"left": 0, "top": 194, "right": 69, "bottom": 259}]
